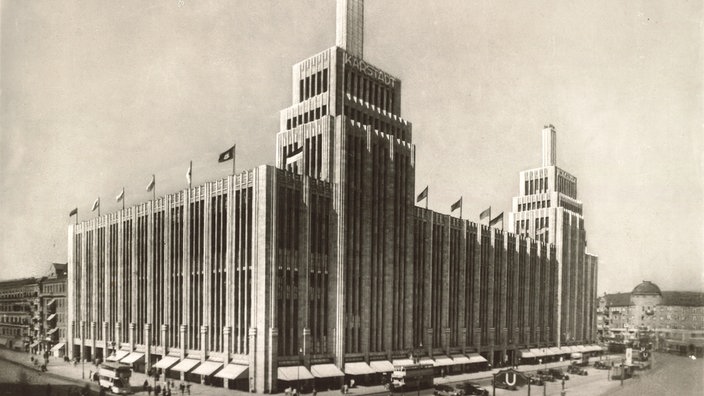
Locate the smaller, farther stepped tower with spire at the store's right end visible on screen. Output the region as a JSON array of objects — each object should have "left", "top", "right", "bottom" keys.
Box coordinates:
[{"left": 508, "top": 125, "right": 598, "bottom": 346}]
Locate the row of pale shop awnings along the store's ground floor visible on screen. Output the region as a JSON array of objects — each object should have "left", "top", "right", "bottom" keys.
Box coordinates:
[{"left": 67, "top": 345, "right": 603, "bottom": 392}]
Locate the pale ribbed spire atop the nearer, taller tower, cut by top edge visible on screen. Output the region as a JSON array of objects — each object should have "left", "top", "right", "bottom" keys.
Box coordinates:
[{"left": 335, "top": 0, "right": 364, "bottom": 58}]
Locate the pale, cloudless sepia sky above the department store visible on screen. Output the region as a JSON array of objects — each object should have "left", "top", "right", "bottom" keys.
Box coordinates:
[{"left": 0, "top": 0, "right": 704, "bottom": 294}]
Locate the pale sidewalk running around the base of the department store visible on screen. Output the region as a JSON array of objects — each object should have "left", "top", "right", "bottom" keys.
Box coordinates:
[{"left": 0, "top": 349, "right": 621, "bottom": 396}]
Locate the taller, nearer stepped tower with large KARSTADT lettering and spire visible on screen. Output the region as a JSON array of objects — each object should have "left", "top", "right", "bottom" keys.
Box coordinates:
[{"left": 276, "top": 0, "right": 415, "bottom": 372}]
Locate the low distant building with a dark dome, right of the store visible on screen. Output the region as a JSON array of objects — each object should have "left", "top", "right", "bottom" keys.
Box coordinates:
[{"left": 597, "top": 281, "right": 704, "bottom": 355}]
